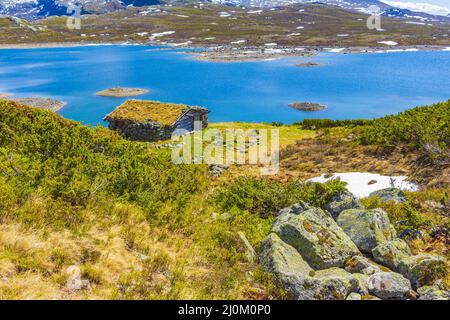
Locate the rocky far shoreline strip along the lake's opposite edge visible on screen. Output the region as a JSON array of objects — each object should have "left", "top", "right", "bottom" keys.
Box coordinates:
[{"left": 0, "top": 41, "right": 450, "bottom": 62}]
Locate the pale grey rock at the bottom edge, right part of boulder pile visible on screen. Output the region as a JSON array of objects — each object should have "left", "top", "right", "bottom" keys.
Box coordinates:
[{"left": 369, "top": 272, "right": 411, "bottom": 299}]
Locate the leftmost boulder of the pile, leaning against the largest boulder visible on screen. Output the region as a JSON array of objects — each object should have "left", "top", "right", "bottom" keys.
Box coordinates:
[{"left": 259, "top": 233, "right": 313, "bottom": 299}]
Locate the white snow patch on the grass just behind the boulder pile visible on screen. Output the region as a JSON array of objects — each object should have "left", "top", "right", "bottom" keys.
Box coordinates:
[{"left": 307, "top": 172, "right": 418, "bottom": 198}]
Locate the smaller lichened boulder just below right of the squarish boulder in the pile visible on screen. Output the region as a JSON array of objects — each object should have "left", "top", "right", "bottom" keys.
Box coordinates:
[{"left": 372, "top": 239, "right": 411, "bottom": 270}]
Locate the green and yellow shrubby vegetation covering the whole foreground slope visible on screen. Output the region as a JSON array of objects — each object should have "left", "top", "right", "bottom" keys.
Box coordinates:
[{"left": 0, "top": 101, "right": 450, "bottom": 299}]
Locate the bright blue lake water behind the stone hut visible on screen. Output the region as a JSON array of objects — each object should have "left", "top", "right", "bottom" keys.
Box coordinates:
[{"left": 0, "top": 46, "right": 450, "bottom": 125}]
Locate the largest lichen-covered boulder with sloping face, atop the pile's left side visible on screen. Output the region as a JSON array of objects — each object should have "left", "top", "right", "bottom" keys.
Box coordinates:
[{"left": 272, "top": 208, "right": 360, "bottom": 270}]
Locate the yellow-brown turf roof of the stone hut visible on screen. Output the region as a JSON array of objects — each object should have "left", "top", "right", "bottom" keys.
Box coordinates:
[{"left": 105, "top": 100, "right": 190, "bottom": 126}]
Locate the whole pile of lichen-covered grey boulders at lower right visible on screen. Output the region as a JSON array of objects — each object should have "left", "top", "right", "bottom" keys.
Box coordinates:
[{"left": 259, "top": 192, "right": 450, "bottom": 300}]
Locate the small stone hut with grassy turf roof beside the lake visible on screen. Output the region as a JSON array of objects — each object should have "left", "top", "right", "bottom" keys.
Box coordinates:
[{"left": 104, "top": 100, "right": 209, "bottom": 142}]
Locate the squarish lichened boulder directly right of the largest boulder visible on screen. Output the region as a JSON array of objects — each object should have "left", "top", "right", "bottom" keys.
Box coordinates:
[{"left": 337, "top": 209, "right": 396, "bottom": 253}]
